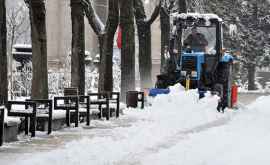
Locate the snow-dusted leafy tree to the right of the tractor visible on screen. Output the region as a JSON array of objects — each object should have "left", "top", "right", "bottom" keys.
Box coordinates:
[{"left": 204, "top": 0, "right": 270, "bottom": 90}]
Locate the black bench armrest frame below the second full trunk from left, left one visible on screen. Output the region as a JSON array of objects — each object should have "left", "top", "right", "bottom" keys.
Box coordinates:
[{"left": 53, "top": 96, "right": 79, "bottom": 127}]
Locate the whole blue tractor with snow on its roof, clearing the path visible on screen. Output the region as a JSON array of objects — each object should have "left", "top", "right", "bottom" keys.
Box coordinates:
[{"left": 156, "top": 13, "right": 233, "bottom": 111}]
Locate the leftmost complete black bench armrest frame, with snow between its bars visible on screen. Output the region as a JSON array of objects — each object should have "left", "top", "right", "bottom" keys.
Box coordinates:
[{"left": 7, "top": 101, "right": 37, "bottom": 137}]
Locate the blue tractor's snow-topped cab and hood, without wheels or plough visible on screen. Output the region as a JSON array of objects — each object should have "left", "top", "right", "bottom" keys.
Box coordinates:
[{"left": 173, "top": 13, "right": 232, "bottom": 85}]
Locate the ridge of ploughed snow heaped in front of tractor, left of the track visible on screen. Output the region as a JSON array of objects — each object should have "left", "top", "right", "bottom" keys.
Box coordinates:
[{"left": 6, "top": 86, "right": 228, "bottom": 165}]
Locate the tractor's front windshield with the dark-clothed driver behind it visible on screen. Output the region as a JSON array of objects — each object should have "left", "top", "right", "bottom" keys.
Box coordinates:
[{"left": 182, "top": 26, "right": 216, "bottom": 54}]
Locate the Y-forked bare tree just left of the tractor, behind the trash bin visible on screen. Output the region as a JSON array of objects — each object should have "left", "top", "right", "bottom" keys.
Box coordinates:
[{"left": 134, "top": 0, "right": 160, "bottom": 89}]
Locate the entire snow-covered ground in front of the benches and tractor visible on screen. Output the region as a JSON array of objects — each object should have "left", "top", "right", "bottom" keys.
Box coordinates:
[{"left": 0, "top": 86, "right": 270, "bottom": 165}]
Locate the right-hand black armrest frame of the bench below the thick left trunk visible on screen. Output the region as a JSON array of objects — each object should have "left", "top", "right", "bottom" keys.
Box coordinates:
[{"left": 26, "top": 99, "right": 53, "bottom": 134}]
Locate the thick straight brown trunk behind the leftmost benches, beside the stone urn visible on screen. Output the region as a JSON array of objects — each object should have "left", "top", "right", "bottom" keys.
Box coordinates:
[{"left": 28, "top": 0, "right": 48, "bottom": 99}]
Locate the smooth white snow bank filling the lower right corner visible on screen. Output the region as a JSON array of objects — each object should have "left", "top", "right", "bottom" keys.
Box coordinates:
[{"left": 141, "top": 96, "right": 270, "bottom": 165}]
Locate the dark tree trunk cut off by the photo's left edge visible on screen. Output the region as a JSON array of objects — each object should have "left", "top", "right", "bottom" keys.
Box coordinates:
[{"left": 0, "top": 0, "right": 8, "bottom": 105}]
